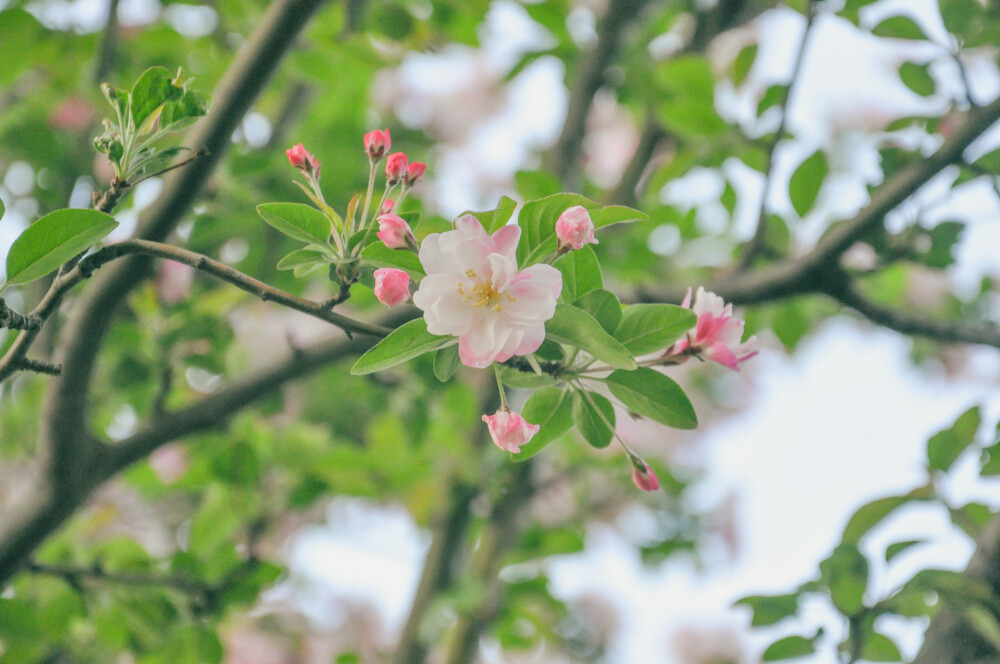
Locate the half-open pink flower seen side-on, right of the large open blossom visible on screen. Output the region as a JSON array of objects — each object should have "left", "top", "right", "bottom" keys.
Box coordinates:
[{"left": 665, "top": 286, "right": 757, "bottom": 371}]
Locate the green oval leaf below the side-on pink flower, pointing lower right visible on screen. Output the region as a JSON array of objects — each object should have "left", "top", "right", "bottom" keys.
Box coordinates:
[{"left": 605, "top": 367, "right": 698, "bottom": 429}]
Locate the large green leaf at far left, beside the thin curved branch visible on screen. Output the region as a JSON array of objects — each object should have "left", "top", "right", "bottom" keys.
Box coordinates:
[{"left": 4, "top": 209, "right": 118, "bottom": 287}]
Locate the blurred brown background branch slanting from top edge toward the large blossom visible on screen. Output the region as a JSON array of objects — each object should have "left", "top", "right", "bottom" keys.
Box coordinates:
[{"left": 552, "top": 0, "right": 648, "bottom": 182}]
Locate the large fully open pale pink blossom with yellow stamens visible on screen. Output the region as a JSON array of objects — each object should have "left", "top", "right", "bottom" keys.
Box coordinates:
[{"left": 413, "top": 214, "right": 562, "bottom": 368}]
